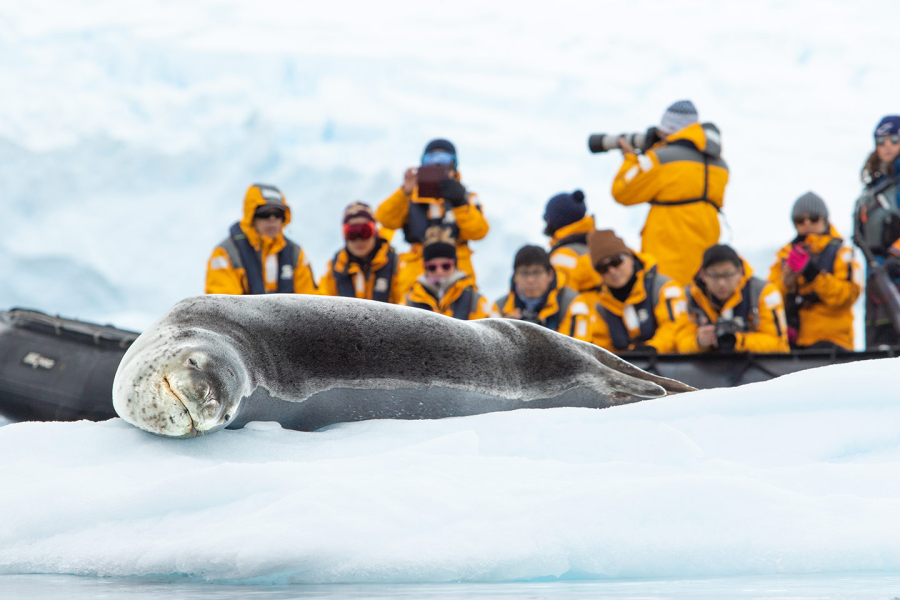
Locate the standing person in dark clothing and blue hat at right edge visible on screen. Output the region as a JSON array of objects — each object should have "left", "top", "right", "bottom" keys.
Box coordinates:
[{"left": 855, "top": 115, "right": 900, "bottom": 348}]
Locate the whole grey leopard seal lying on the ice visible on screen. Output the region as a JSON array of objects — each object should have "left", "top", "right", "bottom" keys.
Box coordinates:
[{"left": 113, "top": 294, "right": 693, "bottom": 438}]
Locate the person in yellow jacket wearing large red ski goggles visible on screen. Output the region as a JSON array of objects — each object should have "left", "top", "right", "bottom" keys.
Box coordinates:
[{"left": 319, "top": 202, "right": 402, "bottom": 304}]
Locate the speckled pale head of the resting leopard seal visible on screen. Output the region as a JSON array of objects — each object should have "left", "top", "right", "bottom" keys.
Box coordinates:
[{"left": 113, "top": 329, "right": 251, "bottom": 438}]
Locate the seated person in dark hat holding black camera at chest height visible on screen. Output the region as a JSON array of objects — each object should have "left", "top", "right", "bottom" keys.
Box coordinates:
[{"left": 678, "top": 244, "right": 790, "bottom": 353}]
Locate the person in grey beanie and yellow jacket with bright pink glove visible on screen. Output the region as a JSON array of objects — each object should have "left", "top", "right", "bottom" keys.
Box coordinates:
[{"left": 769, "top": 192, "right": 862, "bottom": 350}]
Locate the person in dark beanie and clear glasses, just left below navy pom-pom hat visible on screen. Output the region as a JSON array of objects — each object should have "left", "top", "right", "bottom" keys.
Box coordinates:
[{"left": 496, "top": 246, "right": 578, "bottom": 333}]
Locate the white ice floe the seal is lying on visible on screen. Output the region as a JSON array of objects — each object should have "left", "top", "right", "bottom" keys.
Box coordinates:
[{"left": 0, "top": 360, "right": 900, "bottom": 583}]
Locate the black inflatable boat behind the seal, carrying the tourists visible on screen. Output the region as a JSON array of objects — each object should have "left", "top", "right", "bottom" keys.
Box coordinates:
[{"left": 0, "top": 309, "right": 898, "bottom": 421}]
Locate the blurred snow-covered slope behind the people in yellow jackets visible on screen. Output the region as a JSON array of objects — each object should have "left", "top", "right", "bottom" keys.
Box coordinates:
[{"left": 0, "top": 0, "right": 900, "bottom": 328}]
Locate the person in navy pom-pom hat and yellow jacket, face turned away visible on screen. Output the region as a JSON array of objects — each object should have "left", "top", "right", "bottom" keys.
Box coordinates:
[{"left": 544, "top": 190, "right": 600, "bottom": 290}]
